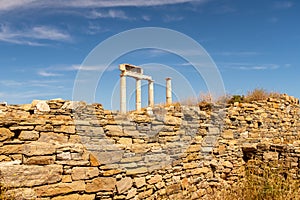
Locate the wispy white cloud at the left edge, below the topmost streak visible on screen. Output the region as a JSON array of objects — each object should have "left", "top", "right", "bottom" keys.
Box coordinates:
[{"left": 0, "top": 24, "right": 71, "bottom": 46}]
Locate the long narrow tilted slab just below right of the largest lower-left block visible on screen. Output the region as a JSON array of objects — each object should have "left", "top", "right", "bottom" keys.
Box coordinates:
[{"left": 34, "top": 181, "right": 85, "bottom": 197}]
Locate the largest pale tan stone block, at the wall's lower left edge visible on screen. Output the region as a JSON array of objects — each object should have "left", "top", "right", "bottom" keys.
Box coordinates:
[{"left": 0, "top": 165, "right": 62, "bottom": 187}]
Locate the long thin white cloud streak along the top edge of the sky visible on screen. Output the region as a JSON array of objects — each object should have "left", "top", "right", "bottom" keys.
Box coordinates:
[{"left": 0, "top": 0, "right": 207, "bottom": 11}]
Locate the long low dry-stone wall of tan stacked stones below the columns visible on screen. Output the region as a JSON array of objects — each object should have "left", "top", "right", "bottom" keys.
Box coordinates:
[{"left": 0, "top": 95, "right": 300, "bottom": 200}]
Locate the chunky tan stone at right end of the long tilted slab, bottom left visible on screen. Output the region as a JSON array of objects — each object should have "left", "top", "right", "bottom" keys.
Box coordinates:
[{"left": 85, "top": 177, "right": 116, "bottom": 193}]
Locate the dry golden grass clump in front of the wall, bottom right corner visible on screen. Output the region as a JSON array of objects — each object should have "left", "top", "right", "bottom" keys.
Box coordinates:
[{"left": 208, "top": 159, "right": 300, "bottom": 200}]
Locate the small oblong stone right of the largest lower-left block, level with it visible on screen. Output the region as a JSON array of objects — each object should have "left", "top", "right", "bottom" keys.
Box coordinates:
[{"left": 72, "top": 167, "right": 99, "bottom": 181}]
